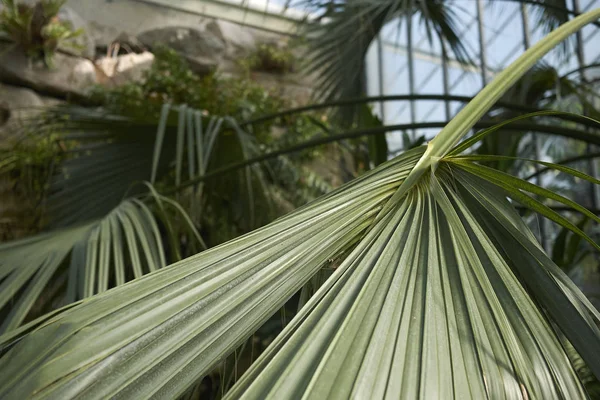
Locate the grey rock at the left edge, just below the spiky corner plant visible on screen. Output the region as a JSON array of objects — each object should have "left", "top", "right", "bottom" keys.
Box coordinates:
[{"left": 0, "top": 45, "right": 97, "bottom": 97}]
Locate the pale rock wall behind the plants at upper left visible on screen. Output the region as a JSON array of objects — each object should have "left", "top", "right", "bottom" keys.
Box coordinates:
[{"left": 0, "top": 0, "right": 314, "bottom": 126}]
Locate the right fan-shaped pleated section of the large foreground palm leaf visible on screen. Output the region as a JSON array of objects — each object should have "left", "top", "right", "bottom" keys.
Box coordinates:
[{"left": 228, "top": 167, "right": 600, "bottom": 399}]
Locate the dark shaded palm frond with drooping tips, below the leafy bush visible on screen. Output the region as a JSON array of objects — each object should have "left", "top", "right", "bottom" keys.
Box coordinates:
[{"left": 46, "top": 104, "right": 266, "bottom": 233}]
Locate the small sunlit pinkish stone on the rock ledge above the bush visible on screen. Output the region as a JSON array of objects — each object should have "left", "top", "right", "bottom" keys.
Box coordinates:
[{"left": 96, "top": 51, "right": 154, "bottom": 86}]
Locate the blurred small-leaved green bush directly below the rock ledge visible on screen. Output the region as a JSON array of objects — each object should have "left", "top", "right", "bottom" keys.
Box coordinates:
[{"left": 92, "top": 47, "right": 336, "bottom": 150}]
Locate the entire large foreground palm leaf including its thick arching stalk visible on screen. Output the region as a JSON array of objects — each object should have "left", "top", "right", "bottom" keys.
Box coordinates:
[{"left": 0, "top": 10, "right": 600, "bottom": 399}]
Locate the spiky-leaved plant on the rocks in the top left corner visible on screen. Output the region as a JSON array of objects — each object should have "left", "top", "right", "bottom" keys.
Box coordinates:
[{"left": 0, "top": 0, "right": 83, "bottom": 67}]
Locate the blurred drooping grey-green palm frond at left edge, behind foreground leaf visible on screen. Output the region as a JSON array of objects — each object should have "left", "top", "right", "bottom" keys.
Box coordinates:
[{"left": 0, "top": 198, "right": 198, "bottom": 332}]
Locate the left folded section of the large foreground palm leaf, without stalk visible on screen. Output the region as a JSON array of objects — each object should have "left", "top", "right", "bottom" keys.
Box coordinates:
[{"left": 0, "top": 148, "right": 423, "bottom": 398}]
